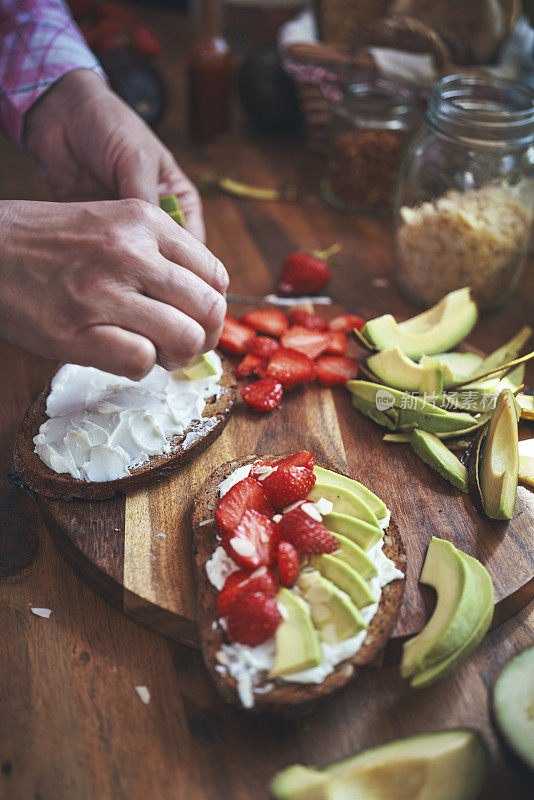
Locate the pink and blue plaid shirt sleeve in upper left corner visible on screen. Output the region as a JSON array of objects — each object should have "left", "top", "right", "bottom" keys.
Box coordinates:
[{"left": 0, "top": 0, "right": 104, "bottom": 146}]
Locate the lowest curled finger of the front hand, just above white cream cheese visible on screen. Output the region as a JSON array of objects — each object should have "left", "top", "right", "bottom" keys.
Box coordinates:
[{"left": 62, "top": 325, "right": 157, "bottom": 381}]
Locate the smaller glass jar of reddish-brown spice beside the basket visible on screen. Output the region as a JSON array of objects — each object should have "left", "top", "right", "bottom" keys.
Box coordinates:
[{"left": 321, "top": 77, "right": 415, "bottom": 214}]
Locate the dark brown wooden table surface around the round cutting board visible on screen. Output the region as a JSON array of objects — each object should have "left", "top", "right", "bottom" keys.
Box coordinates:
[{"left": 0, "top": 6, "right": 534, "bottom": 800}]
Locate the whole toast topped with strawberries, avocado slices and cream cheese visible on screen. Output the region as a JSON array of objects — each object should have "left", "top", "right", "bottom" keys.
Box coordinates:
[{"left": 192, "top": 451, "right": 406, "bottom": 713}]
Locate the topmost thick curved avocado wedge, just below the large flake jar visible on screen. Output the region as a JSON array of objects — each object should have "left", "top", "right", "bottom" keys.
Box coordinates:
[{"left": 362, "top": 287, "right": 477, "bottom": 359}]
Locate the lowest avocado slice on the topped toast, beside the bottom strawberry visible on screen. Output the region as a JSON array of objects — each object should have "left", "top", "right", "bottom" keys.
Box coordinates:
[{"left": 269, "top": 588, "right": 323, "bottom": 678}]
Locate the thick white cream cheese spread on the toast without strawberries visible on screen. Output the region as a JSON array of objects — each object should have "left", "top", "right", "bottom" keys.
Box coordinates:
[{"left": 33, "top": 351, "right": 223, "bottom": 481}]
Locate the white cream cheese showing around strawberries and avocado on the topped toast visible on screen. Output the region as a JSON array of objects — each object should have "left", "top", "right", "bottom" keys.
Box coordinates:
[{"left": 206, "top": 464, "right": 404, "bottom": 708}]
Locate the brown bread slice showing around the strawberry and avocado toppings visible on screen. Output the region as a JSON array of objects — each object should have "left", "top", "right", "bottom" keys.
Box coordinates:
[{"left": 192, "top": 453, "right": 406, "bottom": 714}]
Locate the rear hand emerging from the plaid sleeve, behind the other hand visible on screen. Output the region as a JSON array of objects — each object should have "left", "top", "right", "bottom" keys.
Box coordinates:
[{"left": 25, "top": 69, "right": 205, "bottom": 242}]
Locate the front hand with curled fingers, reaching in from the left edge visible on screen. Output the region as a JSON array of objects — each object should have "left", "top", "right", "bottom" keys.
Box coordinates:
[{"left": 0, "top": 200, "right": 228, "bottom": 379}]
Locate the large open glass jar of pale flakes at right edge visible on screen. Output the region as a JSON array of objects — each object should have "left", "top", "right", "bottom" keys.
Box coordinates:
[{"left": 395, "top": 75, "right": 534, "bottom": 308}]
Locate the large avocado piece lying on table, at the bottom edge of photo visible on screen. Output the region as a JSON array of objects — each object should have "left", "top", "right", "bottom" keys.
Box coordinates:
[{"left": 270, "top": 729, "right": 489, "bottom": 800}]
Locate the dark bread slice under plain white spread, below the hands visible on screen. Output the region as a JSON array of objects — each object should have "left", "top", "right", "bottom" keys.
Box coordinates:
[{"left": 14, "top": 358, "right": 237, "bottom": 500}]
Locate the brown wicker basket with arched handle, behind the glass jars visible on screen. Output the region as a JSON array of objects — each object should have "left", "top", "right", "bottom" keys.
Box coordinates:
[{"left": 284, "top": 0, "right": 521, "bottom": 153}]
